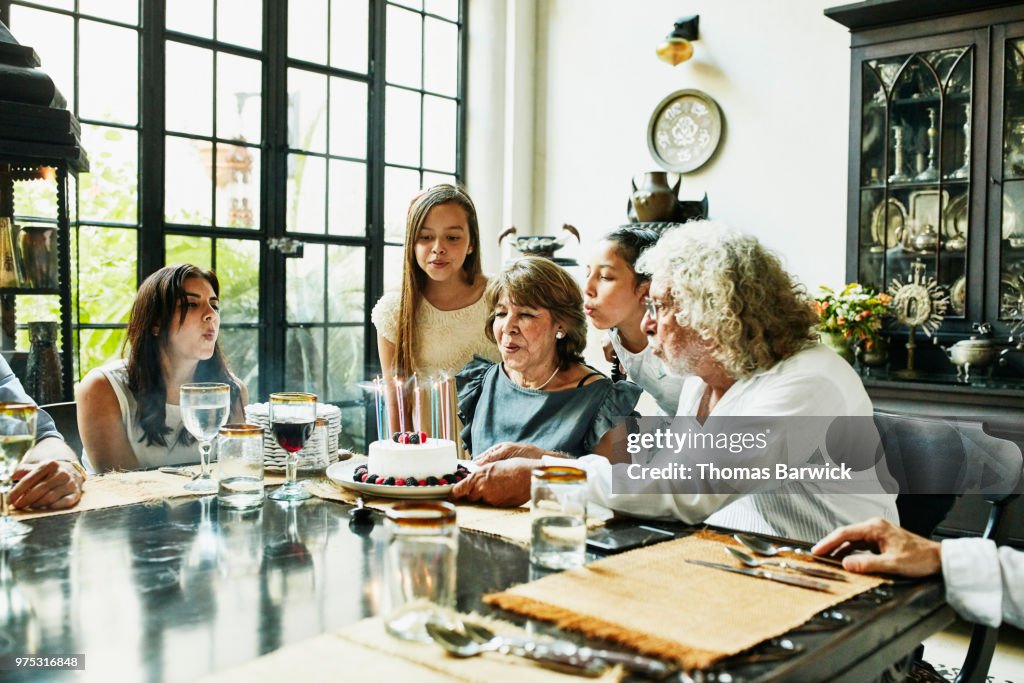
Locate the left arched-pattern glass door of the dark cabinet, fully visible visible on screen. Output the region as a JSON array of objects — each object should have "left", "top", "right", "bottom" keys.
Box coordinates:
[{"left": 858, "top": 46, "right": 970, "bottom": 317}]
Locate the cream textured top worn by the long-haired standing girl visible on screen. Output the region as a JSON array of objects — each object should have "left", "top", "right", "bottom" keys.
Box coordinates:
[{"left": 371, "top": 292, "right": 501, "bottom": 376}]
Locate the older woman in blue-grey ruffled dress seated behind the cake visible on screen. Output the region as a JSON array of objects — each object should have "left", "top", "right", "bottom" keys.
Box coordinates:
[{"left": 456, "top": 257, "right": 641, "bottom": 463}]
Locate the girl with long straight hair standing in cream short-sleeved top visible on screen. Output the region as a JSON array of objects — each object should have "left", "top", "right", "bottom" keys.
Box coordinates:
[{"left": 371, "top": 184, "right": 499, "bottom": 434}]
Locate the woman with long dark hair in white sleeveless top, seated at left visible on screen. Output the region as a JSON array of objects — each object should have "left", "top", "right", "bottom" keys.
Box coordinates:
[{"left": 76, "top": 264, "right": 249, "bottom": 472}]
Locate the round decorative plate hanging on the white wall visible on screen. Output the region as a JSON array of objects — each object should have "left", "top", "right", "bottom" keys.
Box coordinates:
[{"left": 647, "top": 90, "right": 722, "bottom": 173}]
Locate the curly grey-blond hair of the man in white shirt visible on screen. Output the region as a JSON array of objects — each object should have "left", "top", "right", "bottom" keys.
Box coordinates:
[{"left": 637, "top": 221, "right": 817, "bottom": 379}]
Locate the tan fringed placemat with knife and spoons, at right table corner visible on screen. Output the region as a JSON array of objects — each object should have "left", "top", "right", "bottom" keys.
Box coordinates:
[{"left": 483, "top": 530, "right": 887, "bottom": 668}]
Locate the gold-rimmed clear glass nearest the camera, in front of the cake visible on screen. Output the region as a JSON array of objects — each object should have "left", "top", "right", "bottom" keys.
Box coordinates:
[{"left": 384, "top": 501, "right": 459, "bottom": 641}]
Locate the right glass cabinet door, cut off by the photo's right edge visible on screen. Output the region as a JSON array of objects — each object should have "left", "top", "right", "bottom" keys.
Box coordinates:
[{"left": 998, "top": 38, "right": 1024, "bottom": 323}]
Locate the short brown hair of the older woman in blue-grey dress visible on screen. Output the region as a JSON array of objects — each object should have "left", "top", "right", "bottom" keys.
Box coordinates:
[{"left": 483, "top": 256, "right": 587, "bottom": 370}]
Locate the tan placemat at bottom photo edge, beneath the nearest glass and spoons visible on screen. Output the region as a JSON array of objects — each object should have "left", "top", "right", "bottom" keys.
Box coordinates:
[{"left": 196, "top": 616, "right": 620, "bottom": 683}]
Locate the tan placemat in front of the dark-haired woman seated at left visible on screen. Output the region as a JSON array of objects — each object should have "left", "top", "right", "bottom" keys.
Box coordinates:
[{"left": 11, "top": 466, "right": 285, "bottom": 519}]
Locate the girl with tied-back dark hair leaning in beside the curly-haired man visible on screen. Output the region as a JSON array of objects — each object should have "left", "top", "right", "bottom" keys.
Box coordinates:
[{"left": 584, "top": 227, "right": 683, "bottom": 415}]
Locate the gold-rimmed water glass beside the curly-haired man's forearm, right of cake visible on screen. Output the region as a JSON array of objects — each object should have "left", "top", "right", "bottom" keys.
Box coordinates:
[{"left": 529, "top": 465, "right": 587, "bottom": 569}]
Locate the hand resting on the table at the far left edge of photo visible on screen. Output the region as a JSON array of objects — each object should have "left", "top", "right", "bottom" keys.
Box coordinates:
[{"left": 8, "top": 438, "right": 85, "bottom": 510}]
